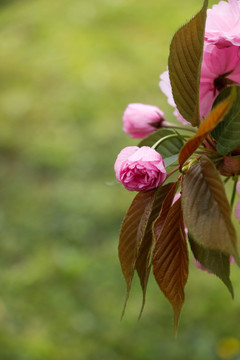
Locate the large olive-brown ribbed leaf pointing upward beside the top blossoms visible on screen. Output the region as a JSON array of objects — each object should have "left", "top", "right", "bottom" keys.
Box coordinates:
[{"left": 168, "top": 0, "right": 208, "bottom": 126}]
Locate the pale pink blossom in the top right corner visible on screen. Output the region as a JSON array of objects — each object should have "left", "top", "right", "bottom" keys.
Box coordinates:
[{"left": 205, "top": 0, "right": 240, "bottom": 48}]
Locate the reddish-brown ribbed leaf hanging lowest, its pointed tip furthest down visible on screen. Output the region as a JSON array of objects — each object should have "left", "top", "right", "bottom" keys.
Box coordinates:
[{"left": 152, "top": 199, "right": 188, "bottom": 331}]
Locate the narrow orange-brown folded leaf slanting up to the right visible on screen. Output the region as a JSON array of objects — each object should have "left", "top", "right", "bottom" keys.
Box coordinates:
[{"left": 178, "top": 92, "right": 236, "bottom": 166}]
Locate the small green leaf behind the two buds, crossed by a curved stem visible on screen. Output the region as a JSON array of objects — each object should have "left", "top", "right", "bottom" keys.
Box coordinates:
[{"left": 138, "top": 129, "right": 183, "bottom": 167}]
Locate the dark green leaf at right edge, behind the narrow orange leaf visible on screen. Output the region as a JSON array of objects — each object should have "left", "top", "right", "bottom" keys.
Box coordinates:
[{"left": 212, "top": 86, "right": 240, "bottom": 156}]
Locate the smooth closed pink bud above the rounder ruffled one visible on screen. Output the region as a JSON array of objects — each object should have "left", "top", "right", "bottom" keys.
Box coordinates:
[{"left": 123, "top": 103, "right": 164, "bottom": 139}]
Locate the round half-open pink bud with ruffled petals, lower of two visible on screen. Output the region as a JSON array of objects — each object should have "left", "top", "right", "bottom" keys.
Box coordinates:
[{"left": 114, "top": 146, "right": 167, "bottom": 191}]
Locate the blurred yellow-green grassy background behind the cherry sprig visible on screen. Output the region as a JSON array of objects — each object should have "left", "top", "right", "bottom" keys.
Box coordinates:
[{"left": 0, "top": 0, "right": 240, "bottom": 360}]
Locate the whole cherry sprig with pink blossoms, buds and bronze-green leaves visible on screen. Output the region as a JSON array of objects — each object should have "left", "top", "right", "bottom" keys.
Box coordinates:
[{"left": 114, "top": 0, "right": 240, "bottom": 325}]
